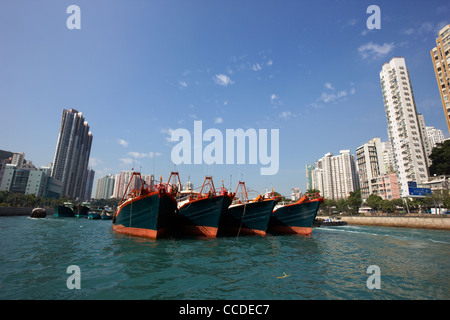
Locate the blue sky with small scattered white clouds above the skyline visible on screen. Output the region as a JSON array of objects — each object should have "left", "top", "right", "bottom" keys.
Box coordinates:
[{"left": 0, "top": 0, "right": 450, "bottom": 196}]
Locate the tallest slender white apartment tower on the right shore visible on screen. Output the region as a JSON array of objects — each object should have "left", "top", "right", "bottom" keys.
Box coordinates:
[{"left": 380, "top": 57, "right": 428, "bottom": 197}]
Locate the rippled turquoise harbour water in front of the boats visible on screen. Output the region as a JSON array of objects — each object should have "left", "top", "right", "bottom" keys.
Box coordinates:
[{"left": 0, "top": 217, "right": 450, "bottom": 300}]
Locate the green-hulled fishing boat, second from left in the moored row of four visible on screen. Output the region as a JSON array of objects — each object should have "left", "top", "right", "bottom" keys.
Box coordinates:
[{"left": 169, "top": 172, "right": 234, "bottom": 238}]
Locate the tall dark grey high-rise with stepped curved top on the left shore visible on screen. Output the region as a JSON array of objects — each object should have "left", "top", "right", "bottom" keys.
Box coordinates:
[{"left": 52, "top": 109, "right": 92, "bottom": 199}]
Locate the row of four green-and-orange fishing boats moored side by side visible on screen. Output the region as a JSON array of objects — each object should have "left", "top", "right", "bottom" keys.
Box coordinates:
[{"left": 112, "top": 172, "right": 323, "bottom": 239}]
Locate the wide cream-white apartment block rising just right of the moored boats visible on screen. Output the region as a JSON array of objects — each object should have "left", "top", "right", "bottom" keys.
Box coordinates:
[{"left": 312, "top": 150, "right": 359, "bottom": 200}]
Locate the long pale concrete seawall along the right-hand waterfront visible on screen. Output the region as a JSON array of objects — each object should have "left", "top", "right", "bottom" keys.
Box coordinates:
[{"left": 340, "top": 215, "right": 450, "bottom": 230}]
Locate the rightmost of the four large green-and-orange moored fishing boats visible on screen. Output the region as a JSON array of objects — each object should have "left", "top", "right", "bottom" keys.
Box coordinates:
[{"left": 268, "top": 193, "right": 324, "bottom": 235}]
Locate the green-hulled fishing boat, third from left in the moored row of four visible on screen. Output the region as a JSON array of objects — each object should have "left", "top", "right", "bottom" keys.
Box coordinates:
[{"left": 219, "top": 181, "right": 280, "bottom": 236}]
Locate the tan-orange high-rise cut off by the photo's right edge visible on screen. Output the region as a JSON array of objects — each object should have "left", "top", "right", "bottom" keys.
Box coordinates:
[{"left": 430, "top": 24, "right": 450, "bottom": 133}]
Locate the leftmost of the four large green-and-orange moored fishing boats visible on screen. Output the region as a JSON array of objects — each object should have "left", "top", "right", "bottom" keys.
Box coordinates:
[{"left": 112, "top": 172, "right": 177, "bottom": 239}]
